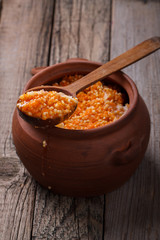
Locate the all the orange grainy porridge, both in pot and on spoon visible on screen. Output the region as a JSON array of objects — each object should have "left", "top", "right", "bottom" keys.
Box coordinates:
[{"left": 17, "top": 74, "right": 129, "bottom": 130}]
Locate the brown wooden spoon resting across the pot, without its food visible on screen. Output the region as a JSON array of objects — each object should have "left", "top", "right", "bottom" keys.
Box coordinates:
[{"left": 19, "top": 37, "right": 160, "bottom": 127}]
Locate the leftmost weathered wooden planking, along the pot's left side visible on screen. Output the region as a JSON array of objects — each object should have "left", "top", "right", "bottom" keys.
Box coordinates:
[{"left": 0, "top": 0, "right": 54, "bottom": 239}]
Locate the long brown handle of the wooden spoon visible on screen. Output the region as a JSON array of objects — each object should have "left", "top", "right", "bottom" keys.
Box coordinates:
[{"left": 66, "top": 37, "right": 160, "bottom": 94}]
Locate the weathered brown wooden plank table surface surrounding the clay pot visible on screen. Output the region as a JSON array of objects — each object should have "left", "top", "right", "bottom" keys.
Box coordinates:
[{"left": 0, "top": 0, "right": 160, "bottom": 240}]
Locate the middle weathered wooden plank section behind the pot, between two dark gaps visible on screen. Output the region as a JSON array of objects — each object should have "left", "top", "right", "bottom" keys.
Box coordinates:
[{"left": 50, "top": 0, "right": 110, "bottom": 64}]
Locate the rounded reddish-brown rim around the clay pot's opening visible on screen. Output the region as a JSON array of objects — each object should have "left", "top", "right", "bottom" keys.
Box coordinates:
[{"left": 24, "top": 58, "right": 139, "bottom": 137}]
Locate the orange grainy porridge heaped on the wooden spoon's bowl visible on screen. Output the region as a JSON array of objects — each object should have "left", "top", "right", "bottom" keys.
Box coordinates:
[{"left": 17, "top": 90, "right": 77, "bottom": 121}]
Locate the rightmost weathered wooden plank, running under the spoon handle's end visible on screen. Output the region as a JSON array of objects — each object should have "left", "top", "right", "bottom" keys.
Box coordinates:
[{"left": 104, "top": 0, "right": 160, "bottom": 240}]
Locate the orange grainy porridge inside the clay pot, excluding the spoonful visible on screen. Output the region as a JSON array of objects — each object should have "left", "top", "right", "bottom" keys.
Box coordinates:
[{"left": 53, "top": 74, "right": 129, "bottom": 130}]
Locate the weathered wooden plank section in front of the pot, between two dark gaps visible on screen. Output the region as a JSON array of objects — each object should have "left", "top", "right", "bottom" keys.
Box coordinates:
[{"left": 32, "top": 187, "right": 104, "bottom": 240}]
